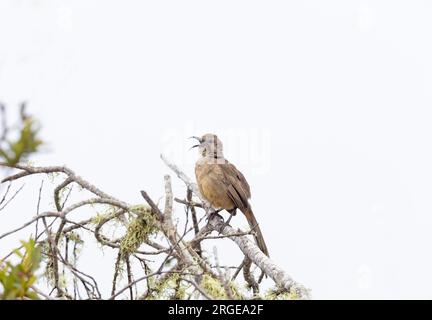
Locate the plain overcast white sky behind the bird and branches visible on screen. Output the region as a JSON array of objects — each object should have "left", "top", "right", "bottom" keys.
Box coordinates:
[{"left": 0, "top": 0, "right": 432, "bottom": 299}]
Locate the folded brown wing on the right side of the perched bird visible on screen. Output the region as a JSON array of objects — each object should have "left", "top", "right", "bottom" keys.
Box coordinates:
[{"left": 220, "top": 162, "right": 251, "bottom": 212}]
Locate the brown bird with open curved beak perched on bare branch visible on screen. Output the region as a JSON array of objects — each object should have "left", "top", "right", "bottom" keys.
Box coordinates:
[{"left": 192, "top": 133, "right": 269, "bottom": 256}]
